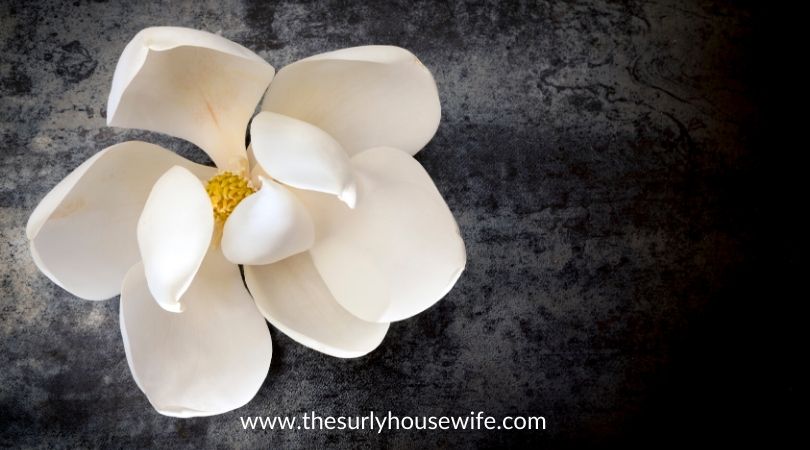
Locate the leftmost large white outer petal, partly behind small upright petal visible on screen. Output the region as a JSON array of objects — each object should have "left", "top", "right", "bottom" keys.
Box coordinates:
[{"left": 26, "top": 141, "right": 215, "bottom": 300}]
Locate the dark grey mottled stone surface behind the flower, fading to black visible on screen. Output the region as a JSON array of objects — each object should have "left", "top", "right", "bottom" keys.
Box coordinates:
[{"left": 0, "top": 0, "right": 784, "bottom": 448}]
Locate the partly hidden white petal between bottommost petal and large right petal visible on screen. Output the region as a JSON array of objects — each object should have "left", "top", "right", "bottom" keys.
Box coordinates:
[{"left": 245, "top": 253, "right": 388, "bottom": 358}]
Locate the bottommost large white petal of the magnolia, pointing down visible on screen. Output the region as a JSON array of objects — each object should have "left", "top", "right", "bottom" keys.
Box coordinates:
[{"left": 121, "top": 248, "right": 272, "bottom": 417}]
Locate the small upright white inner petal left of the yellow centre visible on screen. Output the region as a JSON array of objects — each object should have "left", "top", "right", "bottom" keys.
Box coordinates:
[{"left": 138, "top": 166, "right": 214, "bottom": 312}]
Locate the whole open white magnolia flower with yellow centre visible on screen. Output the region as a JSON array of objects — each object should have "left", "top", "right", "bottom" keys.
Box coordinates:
[{"left": 26, "top": 27, "right": 466, "bottom": 417}]
